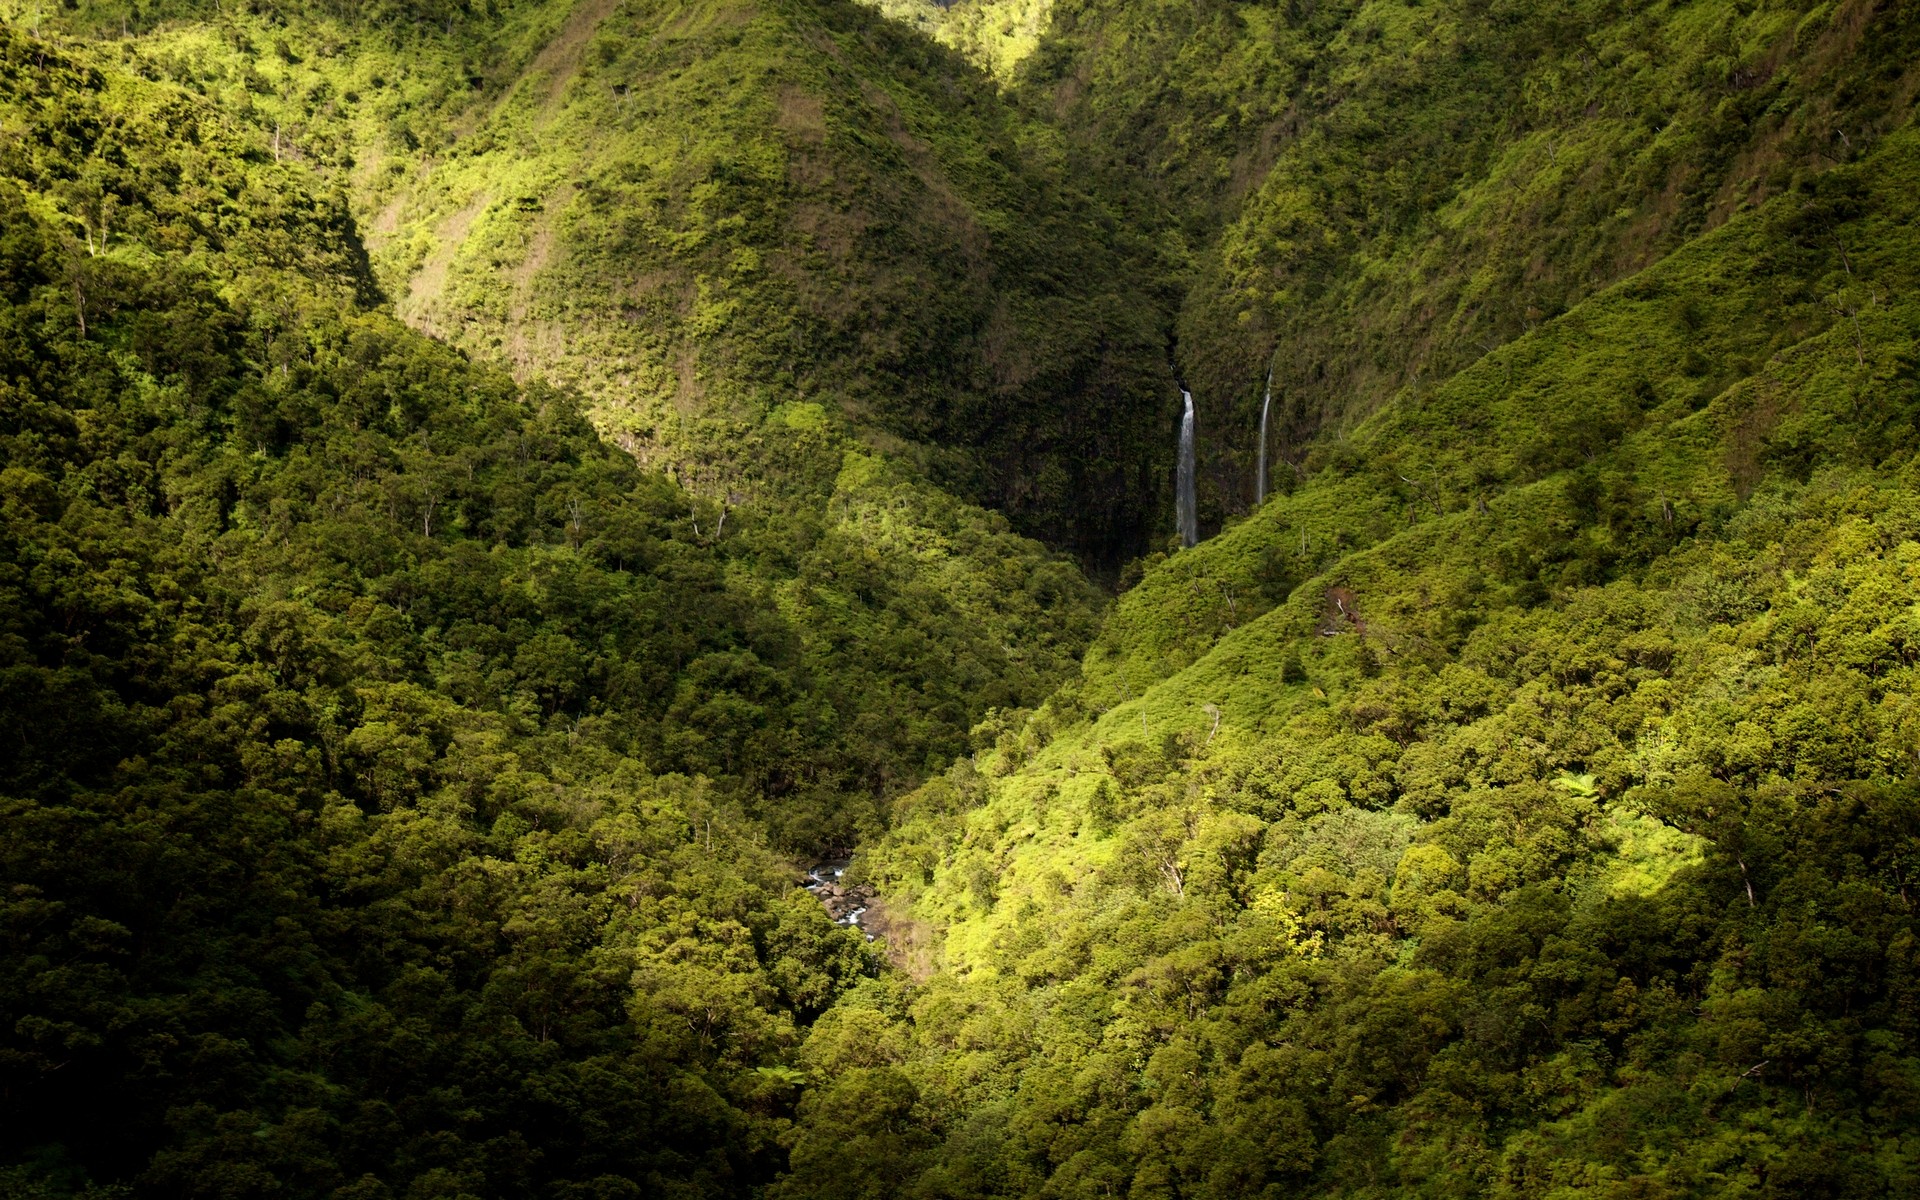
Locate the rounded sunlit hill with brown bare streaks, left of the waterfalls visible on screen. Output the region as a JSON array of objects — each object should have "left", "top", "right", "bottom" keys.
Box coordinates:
[{"left": 84, "top": 0, "right": 1177, "bottom": 570}]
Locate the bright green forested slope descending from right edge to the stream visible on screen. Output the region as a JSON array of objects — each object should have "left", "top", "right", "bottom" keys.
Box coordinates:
[{"left": 783, "top": 117, "right": 1920, "bottom": 1196}]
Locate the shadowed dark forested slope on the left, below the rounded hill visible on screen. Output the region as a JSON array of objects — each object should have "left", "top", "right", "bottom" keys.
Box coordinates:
[{"left": 0, "top": 27, "right": 1094, "bottom": 1196}]
